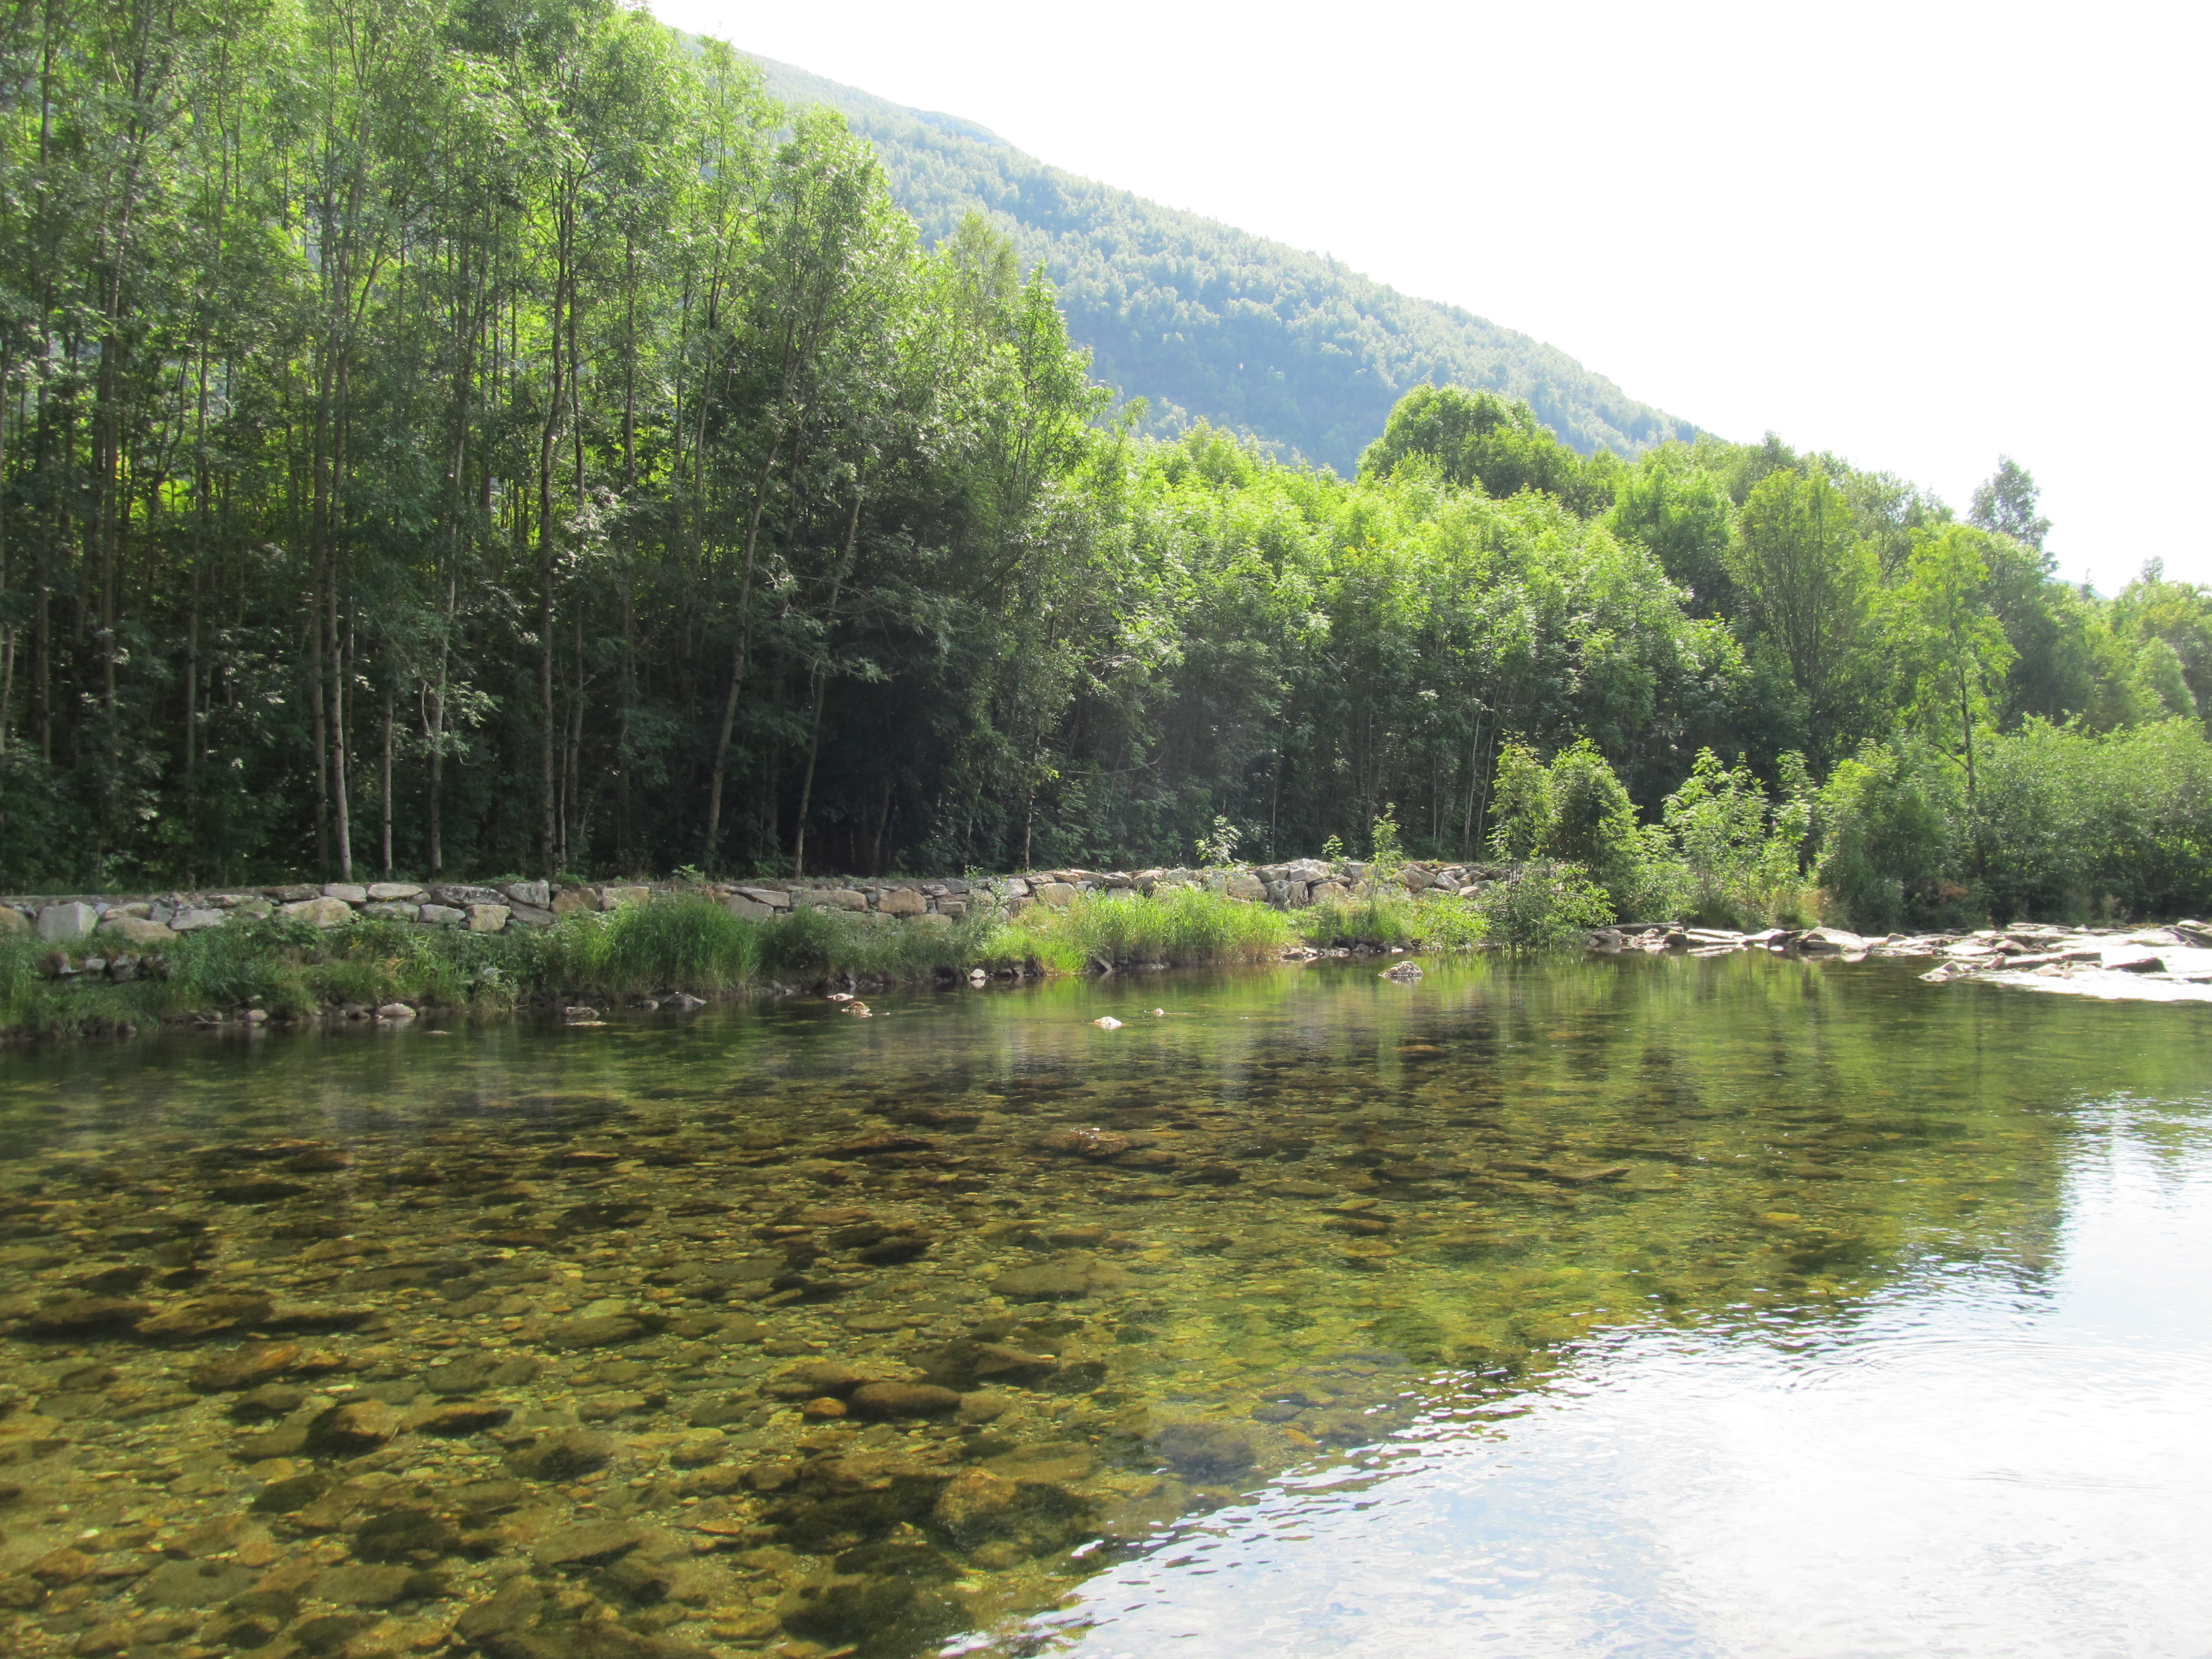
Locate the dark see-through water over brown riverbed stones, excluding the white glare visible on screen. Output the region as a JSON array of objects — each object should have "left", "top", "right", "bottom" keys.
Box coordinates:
[{"left": 0, "top": 956, "right": 2212, "bottom": 1659}]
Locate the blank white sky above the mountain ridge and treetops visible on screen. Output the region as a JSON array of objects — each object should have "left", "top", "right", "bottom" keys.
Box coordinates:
[{"left": 653, "top": 0, "right": 2212, "bottom": 591}]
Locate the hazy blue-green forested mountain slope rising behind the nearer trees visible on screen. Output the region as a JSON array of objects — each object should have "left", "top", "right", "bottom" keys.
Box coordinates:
[{"left": 752, "top": 58, "right": 1697, "bottom": 473}]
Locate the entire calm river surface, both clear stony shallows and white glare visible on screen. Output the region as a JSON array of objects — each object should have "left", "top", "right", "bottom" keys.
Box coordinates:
[{"left": 0, "top": 958, "right": 2212, "bottom": 1657}]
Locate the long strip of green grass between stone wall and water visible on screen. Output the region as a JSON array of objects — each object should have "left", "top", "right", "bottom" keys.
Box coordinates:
[{"left": 0, "top": 887, "right": 1489, "bottom": 1035}]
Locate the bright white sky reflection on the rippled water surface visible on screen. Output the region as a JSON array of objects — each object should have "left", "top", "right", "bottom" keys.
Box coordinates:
[{"left": 1055, "top": 1119, "right": 2212, "bottom": 1659}]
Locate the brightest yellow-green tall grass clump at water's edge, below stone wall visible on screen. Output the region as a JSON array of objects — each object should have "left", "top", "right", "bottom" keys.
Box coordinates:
[{"left": 991, "top": 887, "right": 1296, "bottom": 973}]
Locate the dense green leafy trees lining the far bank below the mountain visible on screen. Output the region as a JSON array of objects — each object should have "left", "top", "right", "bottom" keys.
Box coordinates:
[{"left": 0, "top": 0, "right": 2212, "bottom": 938}]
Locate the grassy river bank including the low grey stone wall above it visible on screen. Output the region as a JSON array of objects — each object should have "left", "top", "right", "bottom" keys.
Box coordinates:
[{"left": 0, "top": 860, "right": 1486, "bottom": 1037}]
